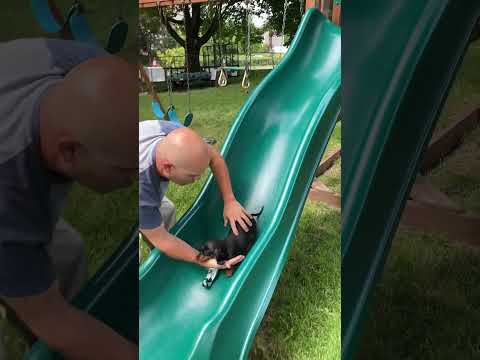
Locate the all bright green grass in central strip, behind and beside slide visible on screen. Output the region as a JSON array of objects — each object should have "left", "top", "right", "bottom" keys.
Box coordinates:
[{"left": 140, "top": 71, "right": 341, "bottom": 360}]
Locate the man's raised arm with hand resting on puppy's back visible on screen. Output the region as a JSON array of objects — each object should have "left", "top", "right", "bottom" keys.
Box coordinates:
[{"left": 209, "top": 146, "right": 252, "bottom": 235}]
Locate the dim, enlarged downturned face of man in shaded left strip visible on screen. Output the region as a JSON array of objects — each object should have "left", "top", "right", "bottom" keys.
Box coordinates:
[{"left": 67, "top": 146, "right": 138, "bottom": 193}]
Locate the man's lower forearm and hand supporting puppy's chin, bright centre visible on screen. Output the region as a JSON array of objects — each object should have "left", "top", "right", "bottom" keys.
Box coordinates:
[{"left": 140, "top": 225, "right": 244, "bottom": 269}]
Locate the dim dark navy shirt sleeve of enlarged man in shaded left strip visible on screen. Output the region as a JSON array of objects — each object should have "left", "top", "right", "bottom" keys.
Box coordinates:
[{"left": 0, "top": 149, "right": 55, "bottom": 297}]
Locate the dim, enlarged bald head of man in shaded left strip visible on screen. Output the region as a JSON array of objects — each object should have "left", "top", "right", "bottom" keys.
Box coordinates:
[{"left": 40, "top": 56, "right": 138, "bottom": 191}]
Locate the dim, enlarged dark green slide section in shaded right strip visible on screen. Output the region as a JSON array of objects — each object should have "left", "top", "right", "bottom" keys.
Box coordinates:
[{"left": 342, "top": 0, "right": 480, "bottom": 359}]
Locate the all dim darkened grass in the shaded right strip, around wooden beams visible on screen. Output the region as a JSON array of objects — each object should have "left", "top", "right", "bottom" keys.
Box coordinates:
[{"left": 358, "top": 41, "right": 480, "bottom": 360}]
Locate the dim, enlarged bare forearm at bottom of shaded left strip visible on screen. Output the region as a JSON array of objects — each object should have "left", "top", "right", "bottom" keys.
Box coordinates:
[{"left": 3, "top": 282, "right": 138, "bottom": 360}]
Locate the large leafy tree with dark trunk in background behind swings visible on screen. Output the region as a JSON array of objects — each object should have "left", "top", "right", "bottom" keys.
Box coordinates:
[{"left": 140, "top": 0, "right": 304, "bottom": 72}]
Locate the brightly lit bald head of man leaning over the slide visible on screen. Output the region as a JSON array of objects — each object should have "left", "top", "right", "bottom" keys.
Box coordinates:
[{"left": 156, "top": 128, "right": 210, "bottom": 185}]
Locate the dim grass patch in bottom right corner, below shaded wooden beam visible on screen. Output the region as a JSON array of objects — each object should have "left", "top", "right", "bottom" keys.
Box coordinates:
[{"left": 358, "top": 232, "right": 480, "bottom": 360}]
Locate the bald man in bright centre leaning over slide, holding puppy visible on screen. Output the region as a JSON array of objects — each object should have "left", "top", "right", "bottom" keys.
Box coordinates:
[{"left": 139, "top": 120, "right": 252, "bottom": 269}]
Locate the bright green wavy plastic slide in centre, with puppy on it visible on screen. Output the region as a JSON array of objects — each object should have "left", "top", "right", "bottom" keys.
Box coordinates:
[{"left": 139, "top": 9, "right": 341, "bottom": 360}]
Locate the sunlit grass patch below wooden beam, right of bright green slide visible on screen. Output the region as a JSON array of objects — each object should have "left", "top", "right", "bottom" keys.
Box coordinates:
[{"left": 250, "top": 202, "right": 341, "bottom": 360}]
